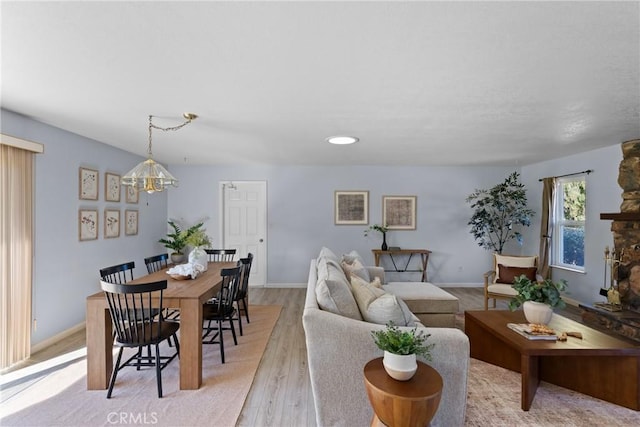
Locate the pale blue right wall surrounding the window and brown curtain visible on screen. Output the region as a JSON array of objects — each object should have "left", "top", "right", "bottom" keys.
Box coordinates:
[{"left": 522, "top": 145, "right": 623, "bottom": 304}]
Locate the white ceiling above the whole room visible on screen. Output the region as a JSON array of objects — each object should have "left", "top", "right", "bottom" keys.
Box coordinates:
[{"left": 0, "top": 0, "right": 640, "bottom": 165}]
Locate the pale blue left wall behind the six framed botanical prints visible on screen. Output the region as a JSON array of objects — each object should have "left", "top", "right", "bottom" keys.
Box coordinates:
[{"left": 0, "top": 110, "right": 167, "bottom": 345}]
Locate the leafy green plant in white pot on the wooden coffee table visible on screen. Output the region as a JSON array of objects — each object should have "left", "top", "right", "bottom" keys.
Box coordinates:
[{"left": 509, "top": 274, "right": 567, "bottom": 325}]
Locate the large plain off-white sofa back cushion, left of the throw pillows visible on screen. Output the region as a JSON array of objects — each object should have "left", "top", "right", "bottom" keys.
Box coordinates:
[{"left": 316, "top": 254, "right": 362, "bottom": 320}]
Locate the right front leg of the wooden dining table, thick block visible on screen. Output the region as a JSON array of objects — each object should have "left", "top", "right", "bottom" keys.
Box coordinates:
[{"left": 180, "top": 299, "right": 202, "bottom": 390}]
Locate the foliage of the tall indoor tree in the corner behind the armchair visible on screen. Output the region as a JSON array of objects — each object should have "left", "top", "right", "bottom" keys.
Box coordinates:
[{"left": 466, "top": 172, "right": 534, "bottom": 254}]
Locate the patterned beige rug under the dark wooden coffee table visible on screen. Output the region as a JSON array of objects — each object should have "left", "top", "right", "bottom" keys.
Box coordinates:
[{"left": 465, "top": 359, "right": 640, "bottom": 427}]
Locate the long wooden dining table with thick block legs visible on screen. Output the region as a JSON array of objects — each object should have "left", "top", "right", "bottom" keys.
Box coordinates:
[{"left": 86, "top": 262, "right": 236, "bottom": 390}]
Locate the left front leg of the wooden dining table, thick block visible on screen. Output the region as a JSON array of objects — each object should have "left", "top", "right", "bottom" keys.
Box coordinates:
[{"left": 86, "top": 299, "right": 113, "bottom": 390}]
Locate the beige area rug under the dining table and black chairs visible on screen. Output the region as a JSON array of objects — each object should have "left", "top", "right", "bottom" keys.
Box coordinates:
[{"left": 0, "top": 305, "right": 282, "bottom": 427}]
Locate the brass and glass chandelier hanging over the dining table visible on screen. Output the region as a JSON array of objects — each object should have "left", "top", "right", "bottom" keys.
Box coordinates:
[{"left": 121, "top": 113, "right": 198, "bottom": 194}]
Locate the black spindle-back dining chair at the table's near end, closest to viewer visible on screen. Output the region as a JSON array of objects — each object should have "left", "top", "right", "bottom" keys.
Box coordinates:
[{"left": 100, "top": 280, "right": 180, "bottom": 399}]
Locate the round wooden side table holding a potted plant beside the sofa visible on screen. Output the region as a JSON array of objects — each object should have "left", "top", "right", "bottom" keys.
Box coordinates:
[{"left": 364, "top": 357, "right": 442, "bottom": 427}]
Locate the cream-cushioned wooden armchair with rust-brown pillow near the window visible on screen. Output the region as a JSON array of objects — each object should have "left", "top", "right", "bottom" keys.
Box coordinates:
[{"left": 484, "top": 254, "right": 538, "bottom": 310}]
